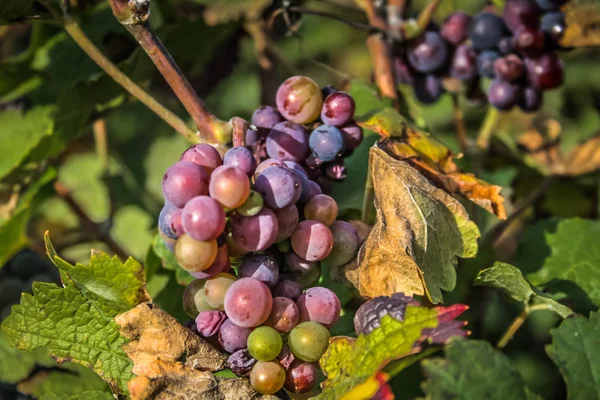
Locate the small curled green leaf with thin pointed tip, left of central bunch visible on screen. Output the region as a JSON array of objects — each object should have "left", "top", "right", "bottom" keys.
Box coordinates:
[{"left": 44, "top": 232, "right": 150, "bottom": 316}]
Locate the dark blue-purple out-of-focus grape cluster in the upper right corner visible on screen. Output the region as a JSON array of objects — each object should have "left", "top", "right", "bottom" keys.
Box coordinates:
[{"left": 394, "top": 0, "right": 566, "bottom": 112}]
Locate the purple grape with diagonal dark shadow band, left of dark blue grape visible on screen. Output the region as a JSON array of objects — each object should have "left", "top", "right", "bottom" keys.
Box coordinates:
[{"left": 266, "top": 121, "right": 309, "bottom": 161}]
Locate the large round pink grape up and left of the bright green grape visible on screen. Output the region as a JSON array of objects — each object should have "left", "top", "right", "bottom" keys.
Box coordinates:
[{"left": 224, "top": 278, "right": 273, "bottom": 328}]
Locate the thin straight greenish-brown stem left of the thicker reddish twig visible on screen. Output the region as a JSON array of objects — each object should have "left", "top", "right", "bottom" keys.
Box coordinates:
[{"left": 63, "top": 18, "right": 198, "bottom": 143}]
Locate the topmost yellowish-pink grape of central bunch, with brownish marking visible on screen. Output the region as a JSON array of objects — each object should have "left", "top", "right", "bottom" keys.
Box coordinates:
[{"left": 275, "top": 76, "right": 323, "bottom": 124}]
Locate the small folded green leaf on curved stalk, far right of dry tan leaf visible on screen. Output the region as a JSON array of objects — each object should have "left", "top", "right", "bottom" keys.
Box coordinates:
[{"left": 475, "top": 262, "right": 573, "bottom": 318}]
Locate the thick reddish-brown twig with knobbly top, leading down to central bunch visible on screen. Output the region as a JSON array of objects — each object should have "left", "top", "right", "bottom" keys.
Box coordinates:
[{"left": 108, "top": 0, "right": 231, "bottom": 144}]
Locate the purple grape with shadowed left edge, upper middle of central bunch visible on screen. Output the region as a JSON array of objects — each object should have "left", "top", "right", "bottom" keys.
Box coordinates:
[{"left": 254, "top": 167, "right": 302, "bottom": 209}]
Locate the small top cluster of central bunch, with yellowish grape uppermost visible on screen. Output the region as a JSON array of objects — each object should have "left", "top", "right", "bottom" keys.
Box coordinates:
[{"left": 246, "top": 76, "right": 363, "bottom": 192}]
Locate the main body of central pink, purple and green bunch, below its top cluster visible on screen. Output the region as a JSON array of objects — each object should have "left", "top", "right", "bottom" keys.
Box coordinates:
[{"left": 158, "top": 137, "right": 362, "bottom": 394}]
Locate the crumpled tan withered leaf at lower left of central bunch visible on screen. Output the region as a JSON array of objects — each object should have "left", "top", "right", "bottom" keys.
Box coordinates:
[{"left": 115, "top": 303, "right": 227, "bottom": 375}]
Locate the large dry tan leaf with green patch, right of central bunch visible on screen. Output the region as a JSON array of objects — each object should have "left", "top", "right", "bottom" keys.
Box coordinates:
[{"left": 345, "top": 147, "right": 479, "bottom": 303}]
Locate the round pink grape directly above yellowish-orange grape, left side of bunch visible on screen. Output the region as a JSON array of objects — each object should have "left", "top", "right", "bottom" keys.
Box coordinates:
[{"left": 181, "top": 196, "right": 226, "bottom": 241}]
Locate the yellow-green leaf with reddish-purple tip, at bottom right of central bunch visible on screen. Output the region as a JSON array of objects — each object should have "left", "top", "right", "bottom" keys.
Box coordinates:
[{"left": 316, "top": 305, "right": 466, "bottom": 400}]
